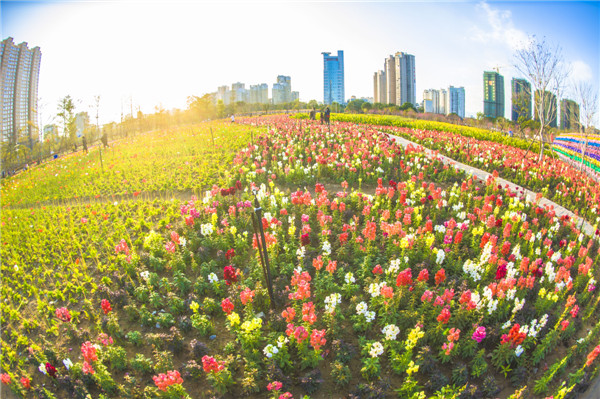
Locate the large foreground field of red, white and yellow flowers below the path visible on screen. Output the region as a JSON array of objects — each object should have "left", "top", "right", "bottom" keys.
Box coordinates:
[{"left": 0, "top": 117, "right": 600, "bottom": 398}]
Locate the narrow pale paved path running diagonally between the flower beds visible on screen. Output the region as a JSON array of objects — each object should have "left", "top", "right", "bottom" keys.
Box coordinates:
[{"left": 388, "top": 134, "right": 600, "bottom": 399}]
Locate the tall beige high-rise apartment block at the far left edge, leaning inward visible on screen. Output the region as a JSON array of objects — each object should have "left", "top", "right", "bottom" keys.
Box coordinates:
[{"left": 0, "top": 37, "right": 42, "bottom": 146}]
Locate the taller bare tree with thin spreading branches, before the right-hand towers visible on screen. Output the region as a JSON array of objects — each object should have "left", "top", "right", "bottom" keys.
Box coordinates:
[{"left": 514, "top": 36, "right": 570, "bottom": 162}]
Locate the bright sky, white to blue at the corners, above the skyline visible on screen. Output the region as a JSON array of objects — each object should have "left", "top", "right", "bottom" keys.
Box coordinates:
[{"left": 0, "top": 0, "right": 600, "bottom": 125}]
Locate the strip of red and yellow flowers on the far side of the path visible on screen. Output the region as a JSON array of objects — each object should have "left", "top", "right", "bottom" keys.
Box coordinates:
[{"left": 314, "top": 115, "right": 600, "bottom": 225}]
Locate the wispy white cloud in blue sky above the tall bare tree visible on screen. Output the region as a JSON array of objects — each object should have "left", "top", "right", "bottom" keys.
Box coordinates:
[{"left": 471, "top": 2, "right": 529, "bottom": 50}]
